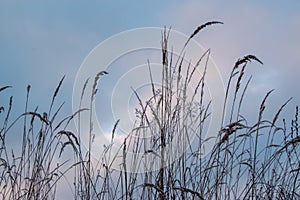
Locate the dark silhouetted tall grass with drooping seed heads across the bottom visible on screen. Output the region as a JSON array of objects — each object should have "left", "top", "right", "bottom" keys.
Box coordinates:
[{"left": 0, "top": 22, "right": 300, "bottom": 199}]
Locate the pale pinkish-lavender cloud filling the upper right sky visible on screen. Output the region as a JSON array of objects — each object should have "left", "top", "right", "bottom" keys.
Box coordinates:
[{"left": 164, "top": 1, "right": 300, "bottom": 120}]
